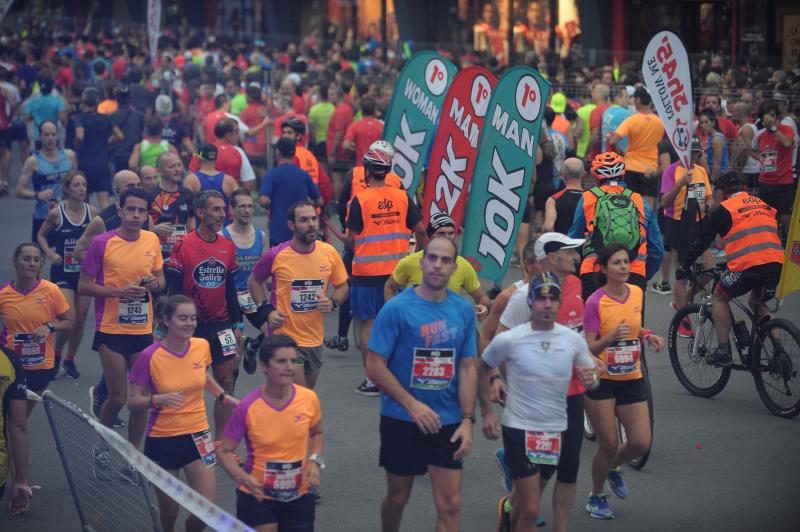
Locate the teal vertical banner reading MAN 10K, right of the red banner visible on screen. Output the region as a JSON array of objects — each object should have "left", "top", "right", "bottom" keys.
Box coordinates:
[{"left": 462, "top": 66, "right": 550, "bottom": 283}]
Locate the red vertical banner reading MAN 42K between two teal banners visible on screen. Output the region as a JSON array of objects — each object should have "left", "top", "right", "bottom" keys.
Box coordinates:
[{"left": 421, "top": 66, "right": 497, "bottom": 228}]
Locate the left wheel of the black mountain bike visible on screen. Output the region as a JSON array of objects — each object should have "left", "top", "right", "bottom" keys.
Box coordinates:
[{"left": 667, "top": 303, "right": 731, "bottom": 397}]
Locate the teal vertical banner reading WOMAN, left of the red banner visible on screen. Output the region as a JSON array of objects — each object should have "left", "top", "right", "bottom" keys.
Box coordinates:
[{"left": 382, "top": 51, "right": 456, "bottom": 198}]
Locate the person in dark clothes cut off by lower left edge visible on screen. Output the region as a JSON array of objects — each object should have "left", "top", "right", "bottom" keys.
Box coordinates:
[{"left": 0, "top": 346, "right": 33, "bottom": 519}]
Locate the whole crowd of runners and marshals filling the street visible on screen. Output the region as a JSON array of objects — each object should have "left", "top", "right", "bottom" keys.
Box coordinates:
[{"left": 0, "top": 13, "right": 800, "bottom": 532}]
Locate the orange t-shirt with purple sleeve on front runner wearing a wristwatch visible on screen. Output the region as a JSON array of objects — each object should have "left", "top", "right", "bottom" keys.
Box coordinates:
[{"left": 224, "top": 384, "right": 322, "bottom": 501}]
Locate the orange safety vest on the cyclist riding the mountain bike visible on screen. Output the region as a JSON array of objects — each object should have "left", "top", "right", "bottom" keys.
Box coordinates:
[{"left": 720, "top": 192, "right": 783, "bottom": 272}]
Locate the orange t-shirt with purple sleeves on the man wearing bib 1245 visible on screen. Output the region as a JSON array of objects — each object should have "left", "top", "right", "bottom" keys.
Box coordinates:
[{"left": 81, "top": 230, "right": 164, "bottom": 334}]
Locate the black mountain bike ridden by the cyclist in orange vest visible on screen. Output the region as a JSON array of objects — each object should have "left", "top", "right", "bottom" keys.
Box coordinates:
[{"left": 668, "top": 264, "right": 800, "bottom": 418}]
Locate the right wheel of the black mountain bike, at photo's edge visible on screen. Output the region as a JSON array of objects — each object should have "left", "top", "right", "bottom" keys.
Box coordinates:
[{"left": 751, "top": 318, "right": 800, "bottom": 418}]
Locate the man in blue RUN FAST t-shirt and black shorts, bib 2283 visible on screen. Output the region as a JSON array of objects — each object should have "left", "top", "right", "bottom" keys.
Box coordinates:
[{"left": 366, "top": 237, "right": 477, "bottom": 532}]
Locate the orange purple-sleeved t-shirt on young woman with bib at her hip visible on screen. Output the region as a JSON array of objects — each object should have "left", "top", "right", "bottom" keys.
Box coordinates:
[{"left": 128, "top": 338, "right": 211, "bottom": 438}]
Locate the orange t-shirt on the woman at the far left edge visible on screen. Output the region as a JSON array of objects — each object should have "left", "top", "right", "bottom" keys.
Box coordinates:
[{"left": 0, "top": 279, "right": 69, "bottom": 371}]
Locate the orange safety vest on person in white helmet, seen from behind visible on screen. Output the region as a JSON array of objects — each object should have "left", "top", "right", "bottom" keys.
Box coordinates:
[{"left": 353, "top": 186, "right": 411, "bottom": 277}]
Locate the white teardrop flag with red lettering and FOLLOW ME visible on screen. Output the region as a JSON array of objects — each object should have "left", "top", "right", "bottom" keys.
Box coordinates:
[{"left": 642, "top": 31, "right": 693, "bottom": 169}]
